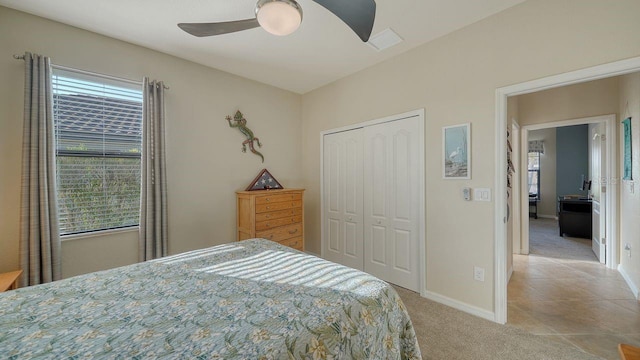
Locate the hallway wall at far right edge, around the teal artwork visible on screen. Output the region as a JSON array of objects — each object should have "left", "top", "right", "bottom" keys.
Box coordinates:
[{"left": 619, "top": 73, "right": 640, "bottom": 295}]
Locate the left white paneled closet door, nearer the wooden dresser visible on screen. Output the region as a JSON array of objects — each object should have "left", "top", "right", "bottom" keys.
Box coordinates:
[{"left": 322, "top": 129, "right": 364, "bottom": 270}]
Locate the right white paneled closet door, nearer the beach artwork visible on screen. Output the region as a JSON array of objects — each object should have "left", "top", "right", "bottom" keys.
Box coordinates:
[{"left": 364, "top": 117, "right": 424, "bottom": 291}]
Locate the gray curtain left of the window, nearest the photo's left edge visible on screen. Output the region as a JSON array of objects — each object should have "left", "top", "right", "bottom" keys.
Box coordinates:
[{"left": 20, "top": 53, "right": 61, "bottom": 286}]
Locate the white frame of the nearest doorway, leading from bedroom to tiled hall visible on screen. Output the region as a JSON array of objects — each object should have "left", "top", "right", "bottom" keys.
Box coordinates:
[{"left": 494, "top": 57, "right": 640, "bottom": 324}]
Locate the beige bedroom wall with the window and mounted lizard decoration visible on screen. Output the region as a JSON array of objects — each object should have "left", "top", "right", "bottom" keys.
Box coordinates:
[{"left": 0, "top": 7, "right": 302, "bottom": 277}]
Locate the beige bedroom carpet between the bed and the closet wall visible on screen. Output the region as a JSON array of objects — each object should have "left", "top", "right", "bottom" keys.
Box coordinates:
[{"left": 396, "top": 287, "right": 599, "bottom": 360}]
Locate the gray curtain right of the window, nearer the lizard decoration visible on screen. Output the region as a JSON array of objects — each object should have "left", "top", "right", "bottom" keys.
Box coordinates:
[{"left": 138, "top": 77, "right": 168, "bottom": 261}]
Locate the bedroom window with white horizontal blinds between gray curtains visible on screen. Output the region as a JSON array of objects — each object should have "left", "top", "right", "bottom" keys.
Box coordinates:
[{"left": 52, "top": 68, "right": 142, "bottom": 235}]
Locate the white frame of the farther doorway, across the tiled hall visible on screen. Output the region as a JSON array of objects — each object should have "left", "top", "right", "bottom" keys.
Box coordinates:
[{"left": 520, "top": 114, "right": 618, "bottom": 260}]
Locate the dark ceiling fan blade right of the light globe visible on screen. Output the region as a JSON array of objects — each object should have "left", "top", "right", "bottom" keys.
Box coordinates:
[{"left": 313, "top": 0, "right": 376, "bottom": 42}]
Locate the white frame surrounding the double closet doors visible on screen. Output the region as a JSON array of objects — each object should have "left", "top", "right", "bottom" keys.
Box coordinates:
[{"left": 320, "top": 109, "right": 427, "bottom": 297}]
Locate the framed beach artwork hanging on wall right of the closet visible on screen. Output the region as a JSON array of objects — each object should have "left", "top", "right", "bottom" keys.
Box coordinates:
[{"left": 442, "top": 123, "right": 471, "bottom": 179}]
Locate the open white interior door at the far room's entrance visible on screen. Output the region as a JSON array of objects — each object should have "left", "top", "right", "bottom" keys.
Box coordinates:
[{"left": 591, "top": 123, "right": 607, "bottom": 263}]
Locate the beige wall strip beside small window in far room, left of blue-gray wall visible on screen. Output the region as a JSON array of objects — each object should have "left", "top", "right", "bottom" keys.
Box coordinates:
[{"left": 529, "top": 128, "right": 556, "bottom": 218}]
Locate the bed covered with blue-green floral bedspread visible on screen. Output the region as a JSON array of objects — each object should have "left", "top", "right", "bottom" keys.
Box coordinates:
[{"left": 0, "top": 239, "right": 420, "bottom": 359}]
